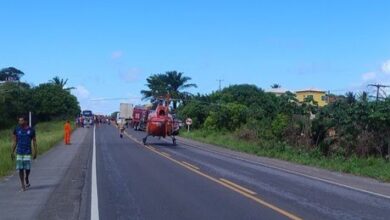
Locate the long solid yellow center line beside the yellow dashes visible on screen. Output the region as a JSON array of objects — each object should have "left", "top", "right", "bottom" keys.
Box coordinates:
[{"left": 124, "top": 132, "right": 302, "bottom": 220}]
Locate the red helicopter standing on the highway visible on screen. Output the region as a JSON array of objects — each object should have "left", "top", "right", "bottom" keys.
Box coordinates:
[{"left": 142, "top": 96, "right": 180, "bottom": 145}]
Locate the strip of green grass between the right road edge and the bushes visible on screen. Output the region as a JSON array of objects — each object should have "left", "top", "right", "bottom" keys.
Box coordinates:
[{"left": 180, "top": 130, "right": 390, "bottom": 182}]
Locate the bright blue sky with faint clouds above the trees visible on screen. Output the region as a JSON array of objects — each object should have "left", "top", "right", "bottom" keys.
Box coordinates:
[{"left": 0, "top": 0, "right": 390, "bottom": 113}]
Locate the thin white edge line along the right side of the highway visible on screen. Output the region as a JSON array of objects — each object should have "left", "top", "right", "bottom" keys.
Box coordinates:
[{"left": 180, "top": 141, "right": 390, "bottom": 199}]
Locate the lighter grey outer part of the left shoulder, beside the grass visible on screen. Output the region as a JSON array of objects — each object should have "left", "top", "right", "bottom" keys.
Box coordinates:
[{"left": 0, "top": 129, "right": 91, "bottom": 219}]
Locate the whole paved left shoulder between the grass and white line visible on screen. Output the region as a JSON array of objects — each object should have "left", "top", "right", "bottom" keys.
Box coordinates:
[{"left": 0, "top": 129, "right": 92, "bottom": 220}]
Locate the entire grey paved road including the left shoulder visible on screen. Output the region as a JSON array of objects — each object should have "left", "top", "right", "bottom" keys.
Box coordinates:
[{"left": 0, "top": 125, "right": 390, "bottom": 219}]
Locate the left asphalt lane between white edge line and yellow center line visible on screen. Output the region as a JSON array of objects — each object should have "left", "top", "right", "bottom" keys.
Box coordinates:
[{"left": 96, "top": 126, "right": 285, "bottom": 220}]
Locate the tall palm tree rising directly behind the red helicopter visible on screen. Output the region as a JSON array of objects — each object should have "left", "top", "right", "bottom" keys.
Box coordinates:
[{"left": 141, "top": 71, "right": 197, "bottom": 110}]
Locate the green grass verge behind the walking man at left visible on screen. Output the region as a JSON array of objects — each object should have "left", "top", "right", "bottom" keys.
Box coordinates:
[{"left": 0, "top": 121, "right": 69, "bottom": 177}]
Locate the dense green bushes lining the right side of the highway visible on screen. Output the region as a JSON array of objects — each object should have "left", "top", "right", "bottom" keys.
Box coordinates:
[{"left": 180, "top": 84, "right": 390, "bottom": 158}]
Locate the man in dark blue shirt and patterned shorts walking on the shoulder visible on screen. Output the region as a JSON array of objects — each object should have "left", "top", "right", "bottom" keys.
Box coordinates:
[{"left": 11, "top": 117, "right": 38, "bottom": 191}]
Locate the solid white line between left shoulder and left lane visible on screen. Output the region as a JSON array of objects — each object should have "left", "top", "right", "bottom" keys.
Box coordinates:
[{"left": 91, "top": 126, "right": 99, "bottom": 220}]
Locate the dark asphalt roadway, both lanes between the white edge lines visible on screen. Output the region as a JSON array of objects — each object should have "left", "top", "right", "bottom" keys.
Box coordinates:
[{"left": 96, "top": 126, "right": 390, "bottom": 219}]
